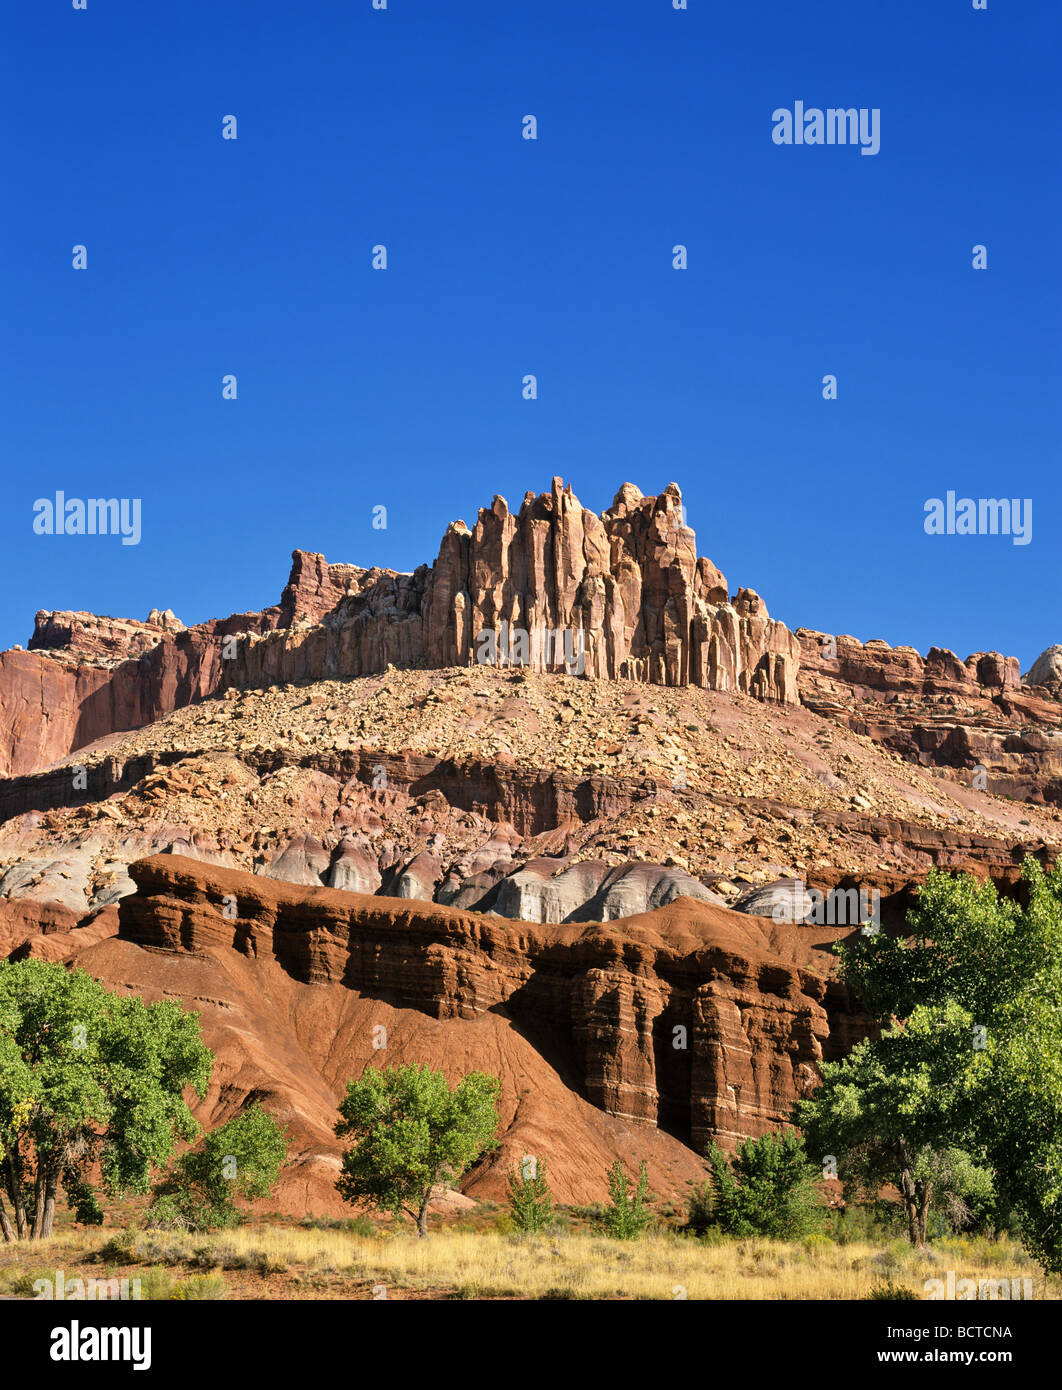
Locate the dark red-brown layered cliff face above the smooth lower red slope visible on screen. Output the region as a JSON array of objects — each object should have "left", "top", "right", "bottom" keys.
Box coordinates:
[{"left": 118, "top": 855, "right": 862, "bottom": 1151}]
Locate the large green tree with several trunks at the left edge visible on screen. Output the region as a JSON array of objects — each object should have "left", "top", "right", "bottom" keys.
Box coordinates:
[{"left": 0, "top": 960, "right": 213, "bottom": 1241}]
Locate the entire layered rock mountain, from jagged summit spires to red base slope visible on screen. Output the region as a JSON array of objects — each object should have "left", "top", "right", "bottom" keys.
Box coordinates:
[{"left": 0, "top": 480, "right": 1062, "bottom": 1212}]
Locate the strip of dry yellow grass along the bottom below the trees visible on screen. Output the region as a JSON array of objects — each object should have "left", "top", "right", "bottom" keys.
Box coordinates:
[{"left": 0, "top": 1222, "right": 1062, "bottom": 1300}]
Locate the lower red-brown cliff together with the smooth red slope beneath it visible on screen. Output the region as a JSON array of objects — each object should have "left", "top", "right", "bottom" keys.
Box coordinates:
[{"left": 8, "top": 855, "right": 863, "bottom": 1212}]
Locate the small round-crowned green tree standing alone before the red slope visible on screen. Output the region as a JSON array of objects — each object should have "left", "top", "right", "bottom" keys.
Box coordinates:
[{"left": 335, "top": 1065, "right": 500, "bottom": 1236}]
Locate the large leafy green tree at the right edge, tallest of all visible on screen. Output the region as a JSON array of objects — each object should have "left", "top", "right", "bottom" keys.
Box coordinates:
[{"left": 795, "top": 859, "right": 1062, "bottom": 1270}]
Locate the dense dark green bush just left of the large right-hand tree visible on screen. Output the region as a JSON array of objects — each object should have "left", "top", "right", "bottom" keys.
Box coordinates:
[{"left": 700, "top": 1130, "right": 823, "bottom": 1240}]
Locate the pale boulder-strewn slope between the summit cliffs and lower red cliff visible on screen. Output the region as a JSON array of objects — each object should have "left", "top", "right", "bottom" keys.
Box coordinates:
[{"left": 0, "top": 669, "right": 1062, "bottom": 922}]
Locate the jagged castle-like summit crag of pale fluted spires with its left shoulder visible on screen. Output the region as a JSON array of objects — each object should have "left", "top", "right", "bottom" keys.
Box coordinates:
[{"left": 215, "top": 478, "right": 799, "bottom": 702}]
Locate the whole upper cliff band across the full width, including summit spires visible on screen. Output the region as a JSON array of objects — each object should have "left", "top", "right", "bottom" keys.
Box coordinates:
[{"left": 0, "top": 478, "right": 1062, "bottom": 805}]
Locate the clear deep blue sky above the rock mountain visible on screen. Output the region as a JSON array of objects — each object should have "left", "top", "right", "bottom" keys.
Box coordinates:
[{"left": 0, "top": 0, "right": 1062, "bottom": 669}]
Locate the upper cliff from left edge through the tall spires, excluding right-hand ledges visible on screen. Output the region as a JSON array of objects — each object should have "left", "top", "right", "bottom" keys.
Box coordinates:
[{"left": 0, "top": 478, "right": 799, "bottom": 776}]
